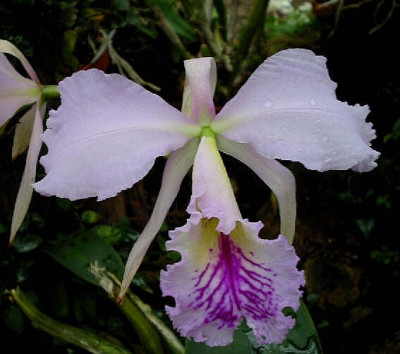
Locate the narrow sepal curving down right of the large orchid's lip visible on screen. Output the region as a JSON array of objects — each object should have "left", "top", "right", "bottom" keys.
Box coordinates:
[{"left": 217, "top": 136, "right": 296, "bottom": 244}]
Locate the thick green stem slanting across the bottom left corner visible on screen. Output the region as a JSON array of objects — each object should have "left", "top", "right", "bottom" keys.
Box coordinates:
[{"left": 11, "top": 289, "right": 131, "bottom": 354}]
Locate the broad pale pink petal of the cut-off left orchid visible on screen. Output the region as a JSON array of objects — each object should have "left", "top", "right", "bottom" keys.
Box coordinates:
[{"left": 0, "top": 53, "right": 40, "bottom": 126}]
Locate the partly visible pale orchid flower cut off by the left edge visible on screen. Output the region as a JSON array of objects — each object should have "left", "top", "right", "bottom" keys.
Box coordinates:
[{"left": 0, "top": 40, "right": 52, "bottom": 243}]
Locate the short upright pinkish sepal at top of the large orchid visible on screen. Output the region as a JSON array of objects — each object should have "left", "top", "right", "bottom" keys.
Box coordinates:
[{"left": 182, "top": 57, "right": 217, "bottom": 124}]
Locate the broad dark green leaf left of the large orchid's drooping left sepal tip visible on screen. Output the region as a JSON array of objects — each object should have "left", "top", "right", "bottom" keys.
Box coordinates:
[{"left": 47, "top": 230, "right": 124, "bottom": 285}]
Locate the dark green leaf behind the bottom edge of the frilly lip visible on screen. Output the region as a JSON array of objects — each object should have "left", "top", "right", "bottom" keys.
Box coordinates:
[{"left": 186, "top": 301, "right": 322, "bottom": 354}]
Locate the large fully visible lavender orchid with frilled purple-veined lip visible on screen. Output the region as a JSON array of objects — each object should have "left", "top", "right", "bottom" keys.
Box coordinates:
[{"left": 34, "top": 49, "right": 379, "bottom": 334}]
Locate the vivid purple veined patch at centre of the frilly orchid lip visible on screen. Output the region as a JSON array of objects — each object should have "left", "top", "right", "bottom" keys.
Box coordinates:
[{"left": 190, "top": 233, "right": 277, "bottom": 328}]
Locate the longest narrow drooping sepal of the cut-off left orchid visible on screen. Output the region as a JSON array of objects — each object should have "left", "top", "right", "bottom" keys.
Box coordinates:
[{"left": 10, "top": 102, "right": 46, "bottom": 243}]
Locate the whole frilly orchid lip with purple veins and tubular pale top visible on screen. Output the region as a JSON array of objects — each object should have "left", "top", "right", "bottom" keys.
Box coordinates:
[{"left": 161, "top": 136, "right": 303, "bottom": 346}]
